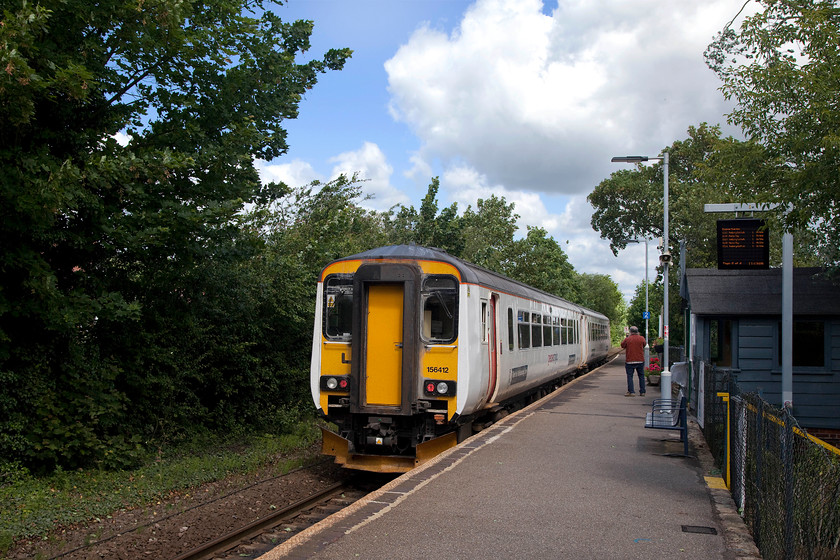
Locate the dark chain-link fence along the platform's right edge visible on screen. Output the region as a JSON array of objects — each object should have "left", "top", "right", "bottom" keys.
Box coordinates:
[{"left": 703, "top": 366, "right": 840, "bottom": 560}]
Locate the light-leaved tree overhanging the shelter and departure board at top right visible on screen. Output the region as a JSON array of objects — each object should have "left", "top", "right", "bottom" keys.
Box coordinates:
[{"left": 706, "top": 0, "right": 840, "bottom": 266}]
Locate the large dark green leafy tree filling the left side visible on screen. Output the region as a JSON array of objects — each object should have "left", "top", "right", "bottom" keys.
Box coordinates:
[{"left": 0, "top": 0, "right": 350, "bottom": 472}]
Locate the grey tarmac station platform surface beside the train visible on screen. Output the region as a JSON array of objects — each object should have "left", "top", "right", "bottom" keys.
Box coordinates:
[{"left": 261, "top": 354, "right": 760, "bottom": 560}]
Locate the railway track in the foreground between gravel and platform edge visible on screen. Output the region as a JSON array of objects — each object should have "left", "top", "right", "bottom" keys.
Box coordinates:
[{"left": 174, "top": 481, "right": 370, "bottom": 560}]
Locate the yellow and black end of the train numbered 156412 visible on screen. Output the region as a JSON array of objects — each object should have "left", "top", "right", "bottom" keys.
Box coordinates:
[{"left": 311, "top": 246, "right": 461, "bottom": 472}]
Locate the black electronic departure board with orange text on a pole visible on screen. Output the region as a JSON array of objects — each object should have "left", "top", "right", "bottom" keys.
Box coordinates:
[{"left": 718, "top": 218, "right": 770, "bottom": 270}]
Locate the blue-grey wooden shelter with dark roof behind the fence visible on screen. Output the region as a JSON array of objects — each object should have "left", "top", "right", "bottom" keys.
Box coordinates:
[{"left": 682, "top": 268, "right": 840, "bottom": 439}]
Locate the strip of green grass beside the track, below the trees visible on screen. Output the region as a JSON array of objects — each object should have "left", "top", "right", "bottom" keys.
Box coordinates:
[{"left": 0, "top": 421, "right": 320, "bottom": 555}]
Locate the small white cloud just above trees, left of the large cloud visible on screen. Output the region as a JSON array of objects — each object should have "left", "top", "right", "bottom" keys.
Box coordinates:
[{"left": 330, "top": 142, "right": 410, "bottom": 211}]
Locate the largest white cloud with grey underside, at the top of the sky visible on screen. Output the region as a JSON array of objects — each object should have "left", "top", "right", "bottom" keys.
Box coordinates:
[{"left": 385, "top": 0, "right": 738, "bottom": 194}]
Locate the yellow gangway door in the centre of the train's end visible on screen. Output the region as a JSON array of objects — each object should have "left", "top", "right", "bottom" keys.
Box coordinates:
[{"left": 364, "top": 284, "right": 405, "bottom": 406}]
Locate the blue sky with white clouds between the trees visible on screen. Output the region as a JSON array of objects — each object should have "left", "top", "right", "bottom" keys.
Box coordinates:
[{"left": 260, "top": 0, "right": 743, "bottom": 306}]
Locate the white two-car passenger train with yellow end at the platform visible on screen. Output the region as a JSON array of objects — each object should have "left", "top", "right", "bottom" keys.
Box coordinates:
[{"left": 310, "top": 245, "right": 610, "bottom": 472}]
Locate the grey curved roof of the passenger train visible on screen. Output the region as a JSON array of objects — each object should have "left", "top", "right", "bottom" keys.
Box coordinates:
[{"left": 324, "top": 245, "right": 607, "bottom": 319}]
